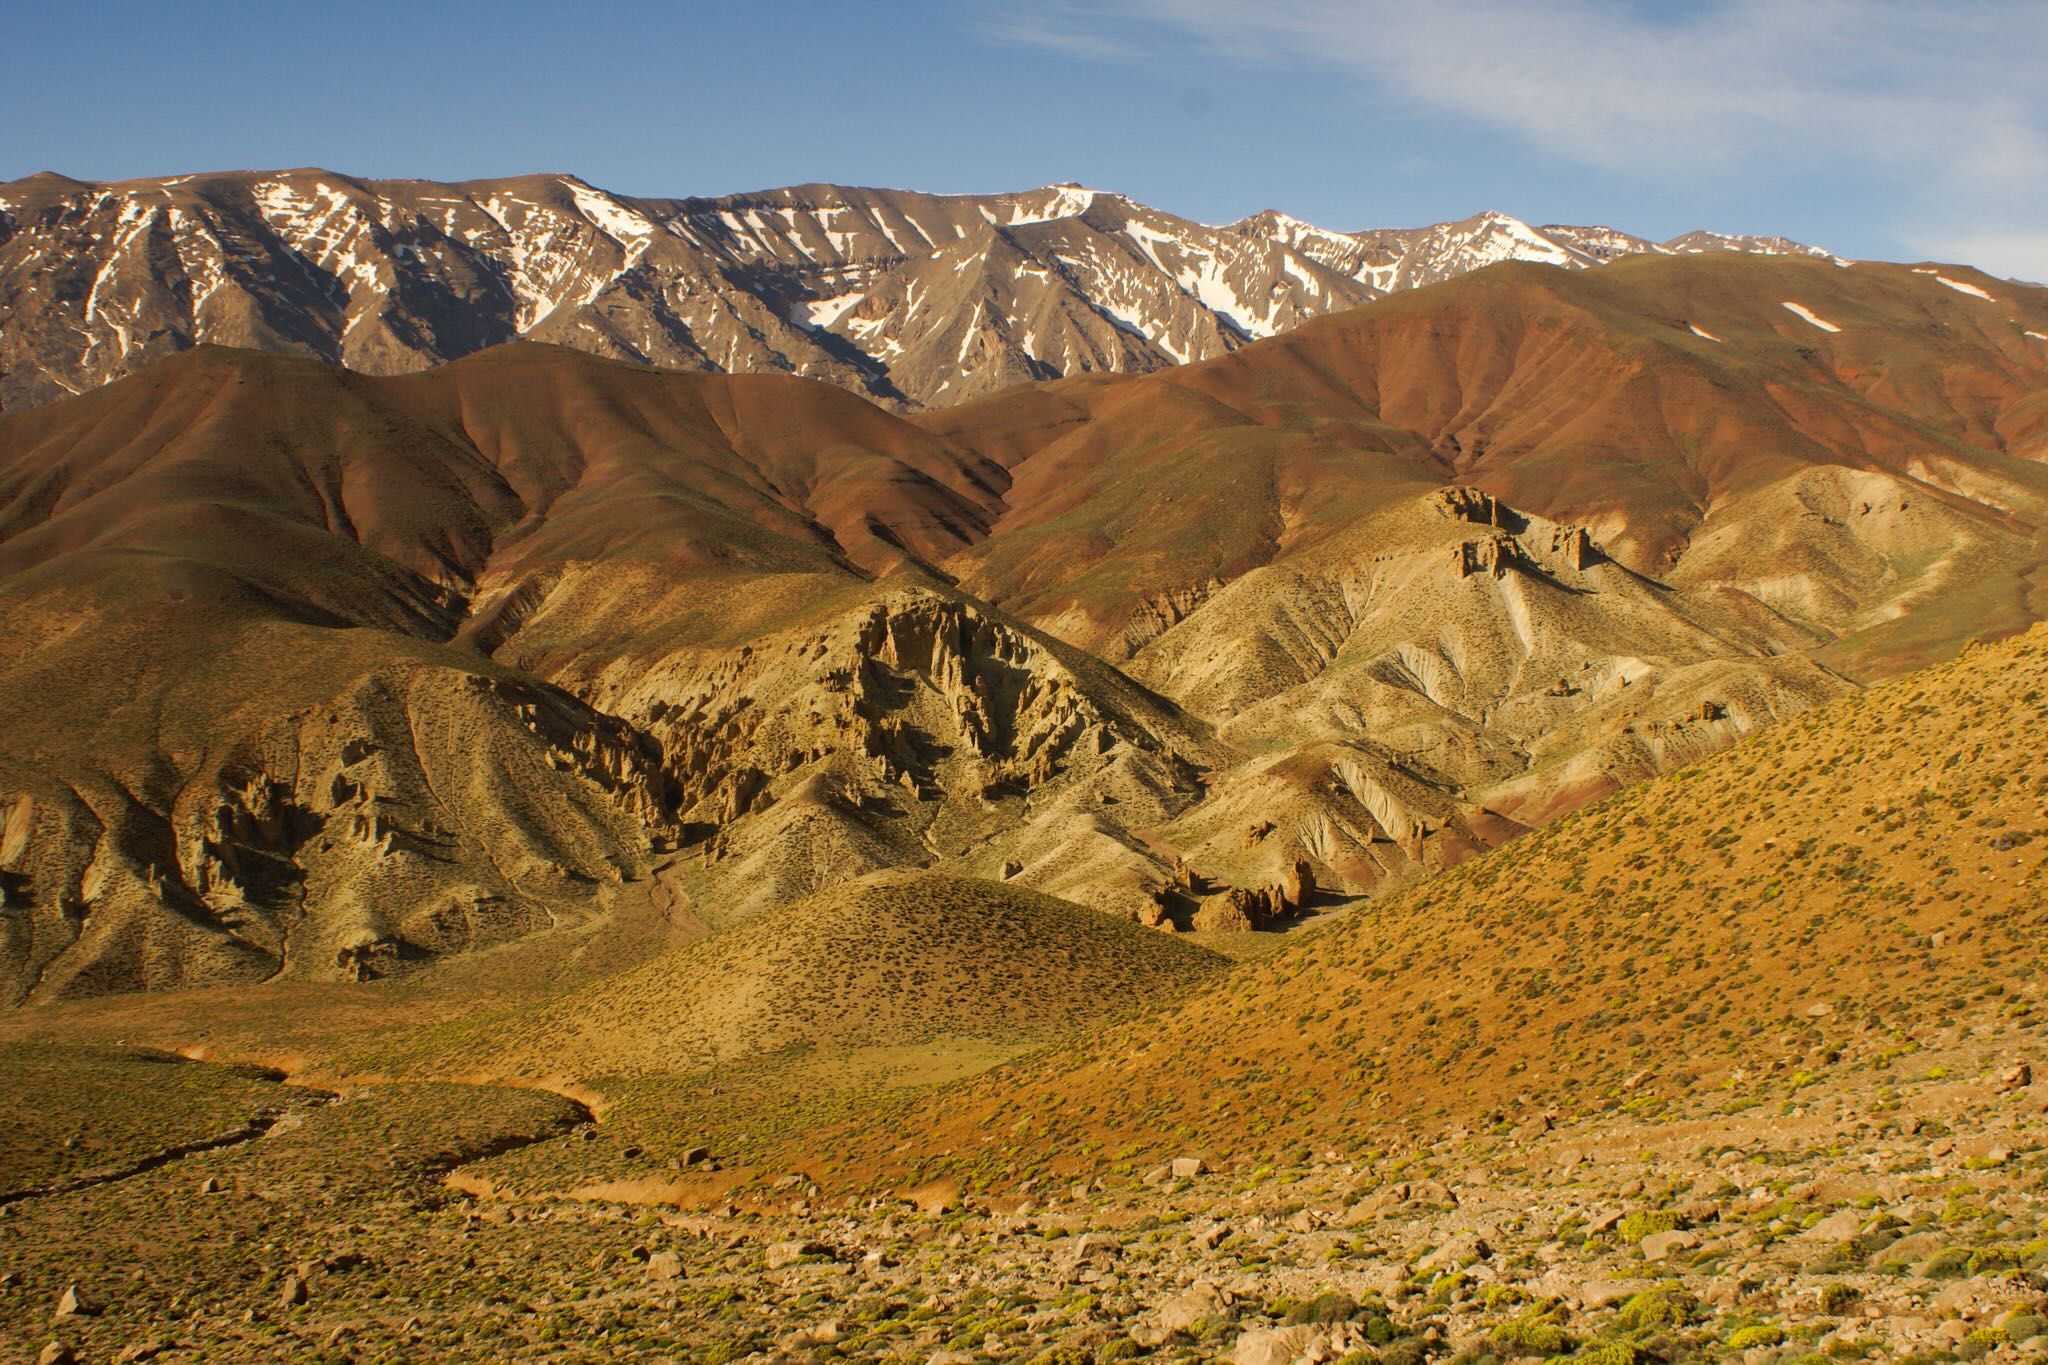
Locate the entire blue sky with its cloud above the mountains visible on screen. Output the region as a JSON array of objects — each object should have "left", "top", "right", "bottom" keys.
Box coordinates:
[{"left": 16, "top": 0, "right": 2048, "bottom": 280}]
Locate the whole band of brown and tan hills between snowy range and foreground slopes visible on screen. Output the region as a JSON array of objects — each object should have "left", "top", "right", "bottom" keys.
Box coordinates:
[{"left": 0, "top": 254, "right": 2048, "bottom": 1001}]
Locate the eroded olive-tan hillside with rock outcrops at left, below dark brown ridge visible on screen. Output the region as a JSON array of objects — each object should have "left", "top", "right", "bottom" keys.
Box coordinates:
[{"left": 0, "top": 667, "right": 674, "bottom": 1003}]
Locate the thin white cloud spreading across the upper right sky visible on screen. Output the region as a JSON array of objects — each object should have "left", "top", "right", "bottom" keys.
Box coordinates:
[{"left": 1014, "top": 0, "right": 2048, "bottom": 278}]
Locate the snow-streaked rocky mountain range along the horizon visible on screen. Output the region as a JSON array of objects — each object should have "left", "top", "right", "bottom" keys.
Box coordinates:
[{"left": 0, "top": 170, "right": 1815, "bottom": 407}]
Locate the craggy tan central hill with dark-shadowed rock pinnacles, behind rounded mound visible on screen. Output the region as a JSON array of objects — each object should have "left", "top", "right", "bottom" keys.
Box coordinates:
[{"left": 569, "top": 587, "right": 1214, "bottom": 915}]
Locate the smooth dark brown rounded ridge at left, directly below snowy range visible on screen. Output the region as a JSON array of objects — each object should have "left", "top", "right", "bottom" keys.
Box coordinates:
[{"left": 0, "top": 344, "right": 1004, "bottom": 585}]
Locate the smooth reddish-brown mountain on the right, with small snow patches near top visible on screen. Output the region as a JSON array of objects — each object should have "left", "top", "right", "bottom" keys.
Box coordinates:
[{"left": 920, "top": 256, "right": 2048, "bottom": 663}]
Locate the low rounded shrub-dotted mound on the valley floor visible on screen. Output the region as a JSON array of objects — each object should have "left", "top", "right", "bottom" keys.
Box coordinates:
[{"left": 426, "top": 874, "right": 1225, "bottom": 1081}]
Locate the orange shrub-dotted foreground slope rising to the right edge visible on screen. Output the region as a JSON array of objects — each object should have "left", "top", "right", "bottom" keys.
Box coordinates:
[{"left": 811, "top": 626, "right": 2048, "bottom": 1179}]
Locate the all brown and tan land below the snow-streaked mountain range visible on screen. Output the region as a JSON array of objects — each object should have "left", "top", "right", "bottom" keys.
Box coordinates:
[{"left": 0, "top": 242, "right": 2048, "bottom": 1365}]
